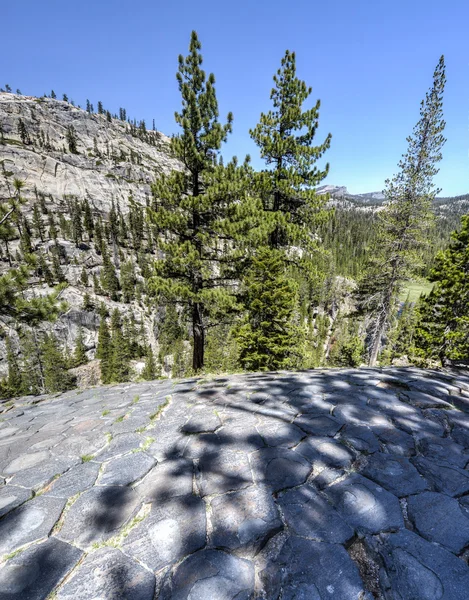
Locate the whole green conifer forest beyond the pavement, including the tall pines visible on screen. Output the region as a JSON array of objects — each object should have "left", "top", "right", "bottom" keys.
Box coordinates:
[{"left": 0, "top": 32, "right": 469, "bottom": 398}]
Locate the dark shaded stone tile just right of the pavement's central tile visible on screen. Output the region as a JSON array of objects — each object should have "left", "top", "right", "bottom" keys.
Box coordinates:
[{"left": 251, "top": 448, "right": 311, "bottom": 492}]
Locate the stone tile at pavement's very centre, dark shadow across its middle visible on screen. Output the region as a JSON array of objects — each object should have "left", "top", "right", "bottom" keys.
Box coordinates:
[{"left": 197, "top": 451, "right": 253, "bottom": 496}]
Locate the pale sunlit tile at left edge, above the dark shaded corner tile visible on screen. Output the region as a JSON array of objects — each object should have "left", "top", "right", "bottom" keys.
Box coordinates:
[{"left": 0, "top": 496, "right": 65, "bottom": 556}]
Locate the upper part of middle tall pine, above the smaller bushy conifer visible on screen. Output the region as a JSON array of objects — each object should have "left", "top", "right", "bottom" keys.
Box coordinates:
[{"left": 250, "top": 50, "right": 331, "bottom": 250}]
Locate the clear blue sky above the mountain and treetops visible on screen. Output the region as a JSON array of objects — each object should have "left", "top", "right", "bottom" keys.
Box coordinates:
[{"left": 0, "top": 0, "right": 469, "bottom": 195}]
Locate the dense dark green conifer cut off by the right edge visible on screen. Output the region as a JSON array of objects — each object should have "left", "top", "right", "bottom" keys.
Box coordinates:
[{"left": 415, "top": 215, "right": 469, "bottom": 365}]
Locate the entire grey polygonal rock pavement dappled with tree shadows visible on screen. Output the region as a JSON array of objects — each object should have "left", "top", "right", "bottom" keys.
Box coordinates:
[{"left": 0, "top": 368, "right": 469, "bottom": 600}]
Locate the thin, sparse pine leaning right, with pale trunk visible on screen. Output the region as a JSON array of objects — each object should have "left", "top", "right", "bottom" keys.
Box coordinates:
[{"left": 361, "top": 56, "right": 446, "bottom": 366}]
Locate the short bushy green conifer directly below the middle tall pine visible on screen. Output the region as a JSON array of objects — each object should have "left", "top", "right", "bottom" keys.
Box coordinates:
[{"left": 237, "top": 248, "right": 299, "bottom": 371}]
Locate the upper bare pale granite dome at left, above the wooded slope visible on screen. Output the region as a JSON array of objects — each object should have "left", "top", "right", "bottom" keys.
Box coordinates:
[{"left": 0, "top": 93, "right": 178, "bottom": 212}]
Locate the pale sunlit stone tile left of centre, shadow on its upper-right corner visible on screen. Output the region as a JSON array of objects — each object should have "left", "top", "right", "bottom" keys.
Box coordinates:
[{"left": 135, "top": 458, "right": 194, "bottom": 503}]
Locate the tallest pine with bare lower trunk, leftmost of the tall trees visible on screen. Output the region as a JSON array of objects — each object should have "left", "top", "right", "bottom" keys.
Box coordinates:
[{"left": 152, "top": 31, "right": 232, "bottom": 371}]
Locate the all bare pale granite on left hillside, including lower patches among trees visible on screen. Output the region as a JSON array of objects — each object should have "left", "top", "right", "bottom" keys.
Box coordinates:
[{"left": 0, "top": 93, "right": 180, "bottom": 376}]
